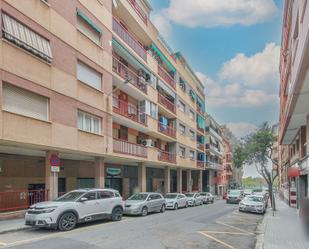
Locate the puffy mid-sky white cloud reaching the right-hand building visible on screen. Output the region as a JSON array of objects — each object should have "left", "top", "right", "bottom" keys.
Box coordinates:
[{"left": 219, "top": 43, "right": 280, "bottom": 86}]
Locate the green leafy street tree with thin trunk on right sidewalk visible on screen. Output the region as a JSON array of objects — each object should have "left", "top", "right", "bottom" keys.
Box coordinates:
[{"left": 246, "top": 122, "right": 278, "bottom": 209}]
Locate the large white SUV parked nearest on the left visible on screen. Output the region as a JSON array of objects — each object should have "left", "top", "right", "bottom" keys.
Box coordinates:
[{"left": 25, "top": 189, "right": 124, "bottom": 231}]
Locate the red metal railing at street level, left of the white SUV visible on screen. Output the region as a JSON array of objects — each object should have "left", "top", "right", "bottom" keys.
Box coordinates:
[{"left": 0, "top": 189, "right": 49, "bottom": 212}]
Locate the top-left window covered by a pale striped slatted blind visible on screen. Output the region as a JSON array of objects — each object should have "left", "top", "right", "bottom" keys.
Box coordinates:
[{"left": 2, "top": 13, "right": 52, "bottom": 62}]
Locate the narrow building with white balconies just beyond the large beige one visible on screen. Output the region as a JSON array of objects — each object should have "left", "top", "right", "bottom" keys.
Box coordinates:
[{"left": 203, "top": 113, "right": 224, "bottom": 194}]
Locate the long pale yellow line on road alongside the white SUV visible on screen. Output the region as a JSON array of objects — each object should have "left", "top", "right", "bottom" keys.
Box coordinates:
[{"left": 0, "top": 219, "right": 128, "bottom": 247}]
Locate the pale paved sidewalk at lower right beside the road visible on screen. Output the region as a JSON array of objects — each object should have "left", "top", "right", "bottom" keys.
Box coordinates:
[{"left": 256, "top": 198, "right": 309, "bottom": 249}]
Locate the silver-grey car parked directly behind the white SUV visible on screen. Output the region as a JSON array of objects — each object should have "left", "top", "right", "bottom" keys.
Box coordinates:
[{"left": 124, "top": 192, "right": 166, "bottom": 216}]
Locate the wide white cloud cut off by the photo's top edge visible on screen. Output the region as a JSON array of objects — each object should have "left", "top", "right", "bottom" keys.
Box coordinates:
[{"left": 162, "top": 0, "right": 278, "bottom": 27}]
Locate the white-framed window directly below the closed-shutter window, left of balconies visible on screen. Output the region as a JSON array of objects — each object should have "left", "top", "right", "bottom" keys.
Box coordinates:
[{"left": 77, "top": 111, "right": 101, "bottom": 134}]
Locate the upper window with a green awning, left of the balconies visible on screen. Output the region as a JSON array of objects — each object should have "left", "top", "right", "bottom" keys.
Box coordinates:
[{"left": 77, "top": 10, "right": 102, "bottom": 45}]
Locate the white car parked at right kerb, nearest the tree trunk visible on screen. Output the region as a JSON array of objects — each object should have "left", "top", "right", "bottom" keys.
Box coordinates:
[{"left": 239, "top": 195, "right": 266, "bottom": 214}]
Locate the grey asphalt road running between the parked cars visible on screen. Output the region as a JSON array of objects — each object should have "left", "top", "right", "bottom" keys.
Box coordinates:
[{"left": 0, "top": 200, "right": 262, "bottom": 249}]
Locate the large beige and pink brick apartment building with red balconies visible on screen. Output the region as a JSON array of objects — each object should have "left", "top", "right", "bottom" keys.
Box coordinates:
[{"left": 0, "top": 0, "right": 206, "bottom": 211}]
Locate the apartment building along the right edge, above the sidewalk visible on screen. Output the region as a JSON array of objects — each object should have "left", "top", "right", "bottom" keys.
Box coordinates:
[{"left": 279, "top": 0, "right": 309, "bottom": 206}]
